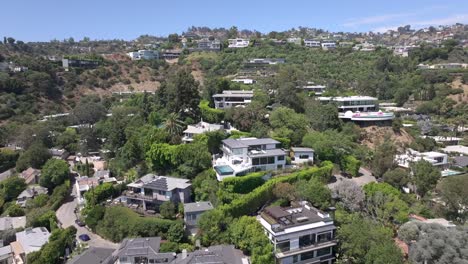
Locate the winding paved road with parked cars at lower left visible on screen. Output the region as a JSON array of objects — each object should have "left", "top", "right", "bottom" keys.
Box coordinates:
[{"left": 56, "top": 184, "right": 118, "bottom": 248}]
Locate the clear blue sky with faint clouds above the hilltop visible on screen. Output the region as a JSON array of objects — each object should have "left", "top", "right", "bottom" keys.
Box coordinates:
[{"left": 0, "top": 0, "right": 468, "bottom": 41}]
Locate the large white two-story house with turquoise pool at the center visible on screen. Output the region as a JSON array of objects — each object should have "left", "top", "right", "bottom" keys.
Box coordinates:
[{"left": 213, "top": 138, "right": 286, "bottom": 181}]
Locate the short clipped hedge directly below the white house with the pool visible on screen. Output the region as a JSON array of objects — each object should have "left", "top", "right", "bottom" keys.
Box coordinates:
[{"left": 219, "top": 172, "right": 266, "bottom": 194}]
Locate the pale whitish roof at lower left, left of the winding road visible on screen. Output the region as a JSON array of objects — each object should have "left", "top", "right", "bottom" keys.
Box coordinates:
[{"left": 16, "top": 227, "right": 50, "bottom": 254}]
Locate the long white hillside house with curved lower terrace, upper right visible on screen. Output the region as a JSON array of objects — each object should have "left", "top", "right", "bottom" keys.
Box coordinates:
[{"left": 318, "top": 96, "right": 395, "bottom": 124}]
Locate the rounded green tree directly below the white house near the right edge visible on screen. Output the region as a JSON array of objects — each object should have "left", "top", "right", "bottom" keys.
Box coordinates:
[{"left": 411, "top": 160, "right": 440, "bottom": 196}]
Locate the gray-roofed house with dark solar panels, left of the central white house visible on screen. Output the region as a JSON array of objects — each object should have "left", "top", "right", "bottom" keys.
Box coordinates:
[{"left": 122, "top": 174, "right": 192, "bottom": 210}]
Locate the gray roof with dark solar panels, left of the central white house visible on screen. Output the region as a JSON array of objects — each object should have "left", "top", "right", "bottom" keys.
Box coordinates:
[{"left": 128, "top": 174, "right": 192, "bottom": 191}]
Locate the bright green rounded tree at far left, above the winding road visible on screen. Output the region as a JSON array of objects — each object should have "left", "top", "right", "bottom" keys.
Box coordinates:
[{"left": 39, "top": 159, "right": 69, "bottom": 190}]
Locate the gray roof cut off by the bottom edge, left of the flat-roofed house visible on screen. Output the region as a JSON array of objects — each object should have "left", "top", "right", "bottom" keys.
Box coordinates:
[{"left": 173, "top": 245, "right": 245, "bottom": 264}]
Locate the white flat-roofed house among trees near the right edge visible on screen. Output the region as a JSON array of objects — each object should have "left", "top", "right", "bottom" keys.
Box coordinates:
[{"left": 395, "top": 149, "right": 448, "bottom": 168}]
